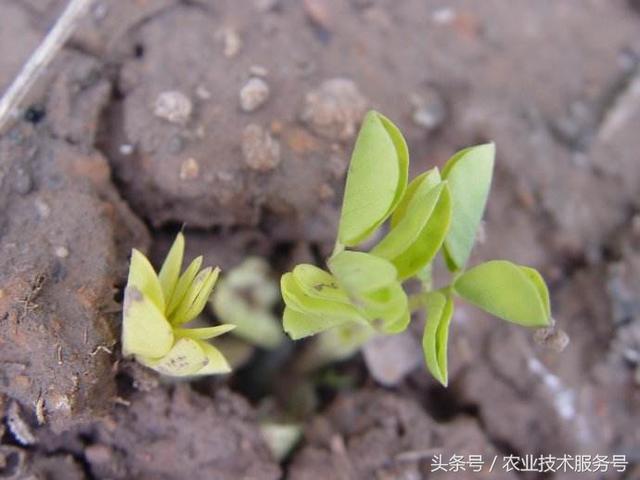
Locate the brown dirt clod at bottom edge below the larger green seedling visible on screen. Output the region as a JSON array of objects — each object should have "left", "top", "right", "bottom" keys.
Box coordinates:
[{"left": 288, "top": 390, "right": 514, "bottom": 480}]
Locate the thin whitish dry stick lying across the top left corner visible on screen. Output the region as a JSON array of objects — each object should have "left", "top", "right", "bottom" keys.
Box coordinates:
[{"left": 0, "top": 0, "right": 92, "bottom": 133}]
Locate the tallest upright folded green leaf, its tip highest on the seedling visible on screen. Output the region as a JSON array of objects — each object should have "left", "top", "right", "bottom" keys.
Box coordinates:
[{"left": 338, "top": 111, "right": 409, "bottom": 246}]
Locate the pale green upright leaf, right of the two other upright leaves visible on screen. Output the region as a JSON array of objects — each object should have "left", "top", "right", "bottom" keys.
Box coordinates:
[{"left": 442, "top": 143, "right": 495, "bottom": 271}]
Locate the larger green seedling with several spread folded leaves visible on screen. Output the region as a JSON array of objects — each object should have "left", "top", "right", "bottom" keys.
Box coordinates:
[{"left": 281, "top": 111, "right": 552, "bottom": 386}]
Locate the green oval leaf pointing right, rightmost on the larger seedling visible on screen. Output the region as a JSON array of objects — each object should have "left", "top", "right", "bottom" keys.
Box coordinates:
[{"left": 454, "top": 260, "right": 551, "bottom": 327}]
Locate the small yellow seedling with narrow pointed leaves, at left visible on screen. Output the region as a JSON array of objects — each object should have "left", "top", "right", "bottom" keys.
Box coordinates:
[{"left": 122, "top": 233, "right": 234, "bottom": 377}]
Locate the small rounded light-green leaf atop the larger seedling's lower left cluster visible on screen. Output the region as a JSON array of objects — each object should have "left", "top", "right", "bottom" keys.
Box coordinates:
[{"left": 328, "top": 251, "right": 398, "bottom": 296}]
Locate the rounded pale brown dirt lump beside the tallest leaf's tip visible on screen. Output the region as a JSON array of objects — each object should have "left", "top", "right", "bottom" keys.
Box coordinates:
[{"left": 300, "top": 78, "right": 368, "bottom": 140}]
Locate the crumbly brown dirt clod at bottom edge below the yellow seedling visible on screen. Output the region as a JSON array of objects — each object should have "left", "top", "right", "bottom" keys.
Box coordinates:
[{"left": 86, "top": 385, "right": 280, "bottom": 480}]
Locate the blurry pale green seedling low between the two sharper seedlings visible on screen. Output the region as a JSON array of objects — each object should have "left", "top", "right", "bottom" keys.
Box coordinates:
[{"left": 210, "top": 257, "right": 285, "bottom": 349}]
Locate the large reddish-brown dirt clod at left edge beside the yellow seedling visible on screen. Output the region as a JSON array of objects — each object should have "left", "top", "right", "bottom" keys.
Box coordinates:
[{"left": 0, "top": 126, "right": 148, "bottom": 432}]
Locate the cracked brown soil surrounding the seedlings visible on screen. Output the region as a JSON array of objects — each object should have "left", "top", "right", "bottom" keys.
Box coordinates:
[{"left": 0, "top": 0, "right": 640, "bottom": 480}]
